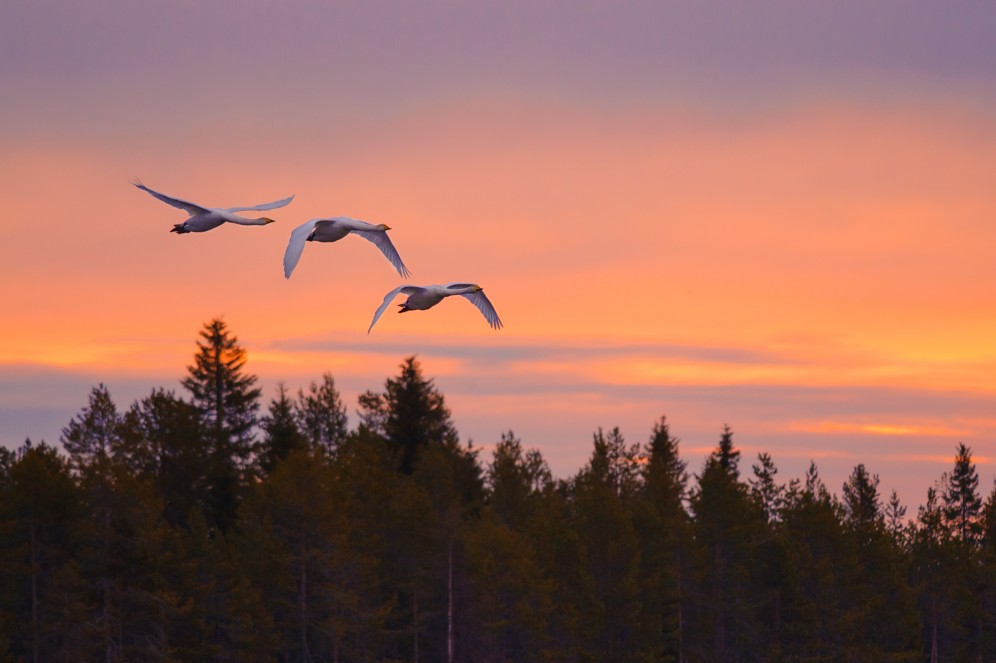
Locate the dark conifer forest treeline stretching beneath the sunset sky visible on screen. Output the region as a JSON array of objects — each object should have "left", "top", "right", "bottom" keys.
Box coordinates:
[{"left": 0, "top": 320, "right": 996, "bottom": 662}]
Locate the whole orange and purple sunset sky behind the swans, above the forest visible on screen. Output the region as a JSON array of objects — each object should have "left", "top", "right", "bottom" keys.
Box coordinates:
[{"left": 0, "top": 0, "right": 996, "bottom": 511}]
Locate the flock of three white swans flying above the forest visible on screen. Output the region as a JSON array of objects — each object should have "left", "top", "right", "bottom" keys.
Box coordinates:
[{"left": 133, "top": 181, "right": 502, "bottom": 334}]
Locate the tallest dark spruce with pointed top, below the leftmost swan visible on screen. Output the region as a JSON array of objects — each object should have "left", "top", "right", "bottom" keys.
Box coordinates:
[{"left": 181, "top": 319, "right": 261, "bottom": 530}]
